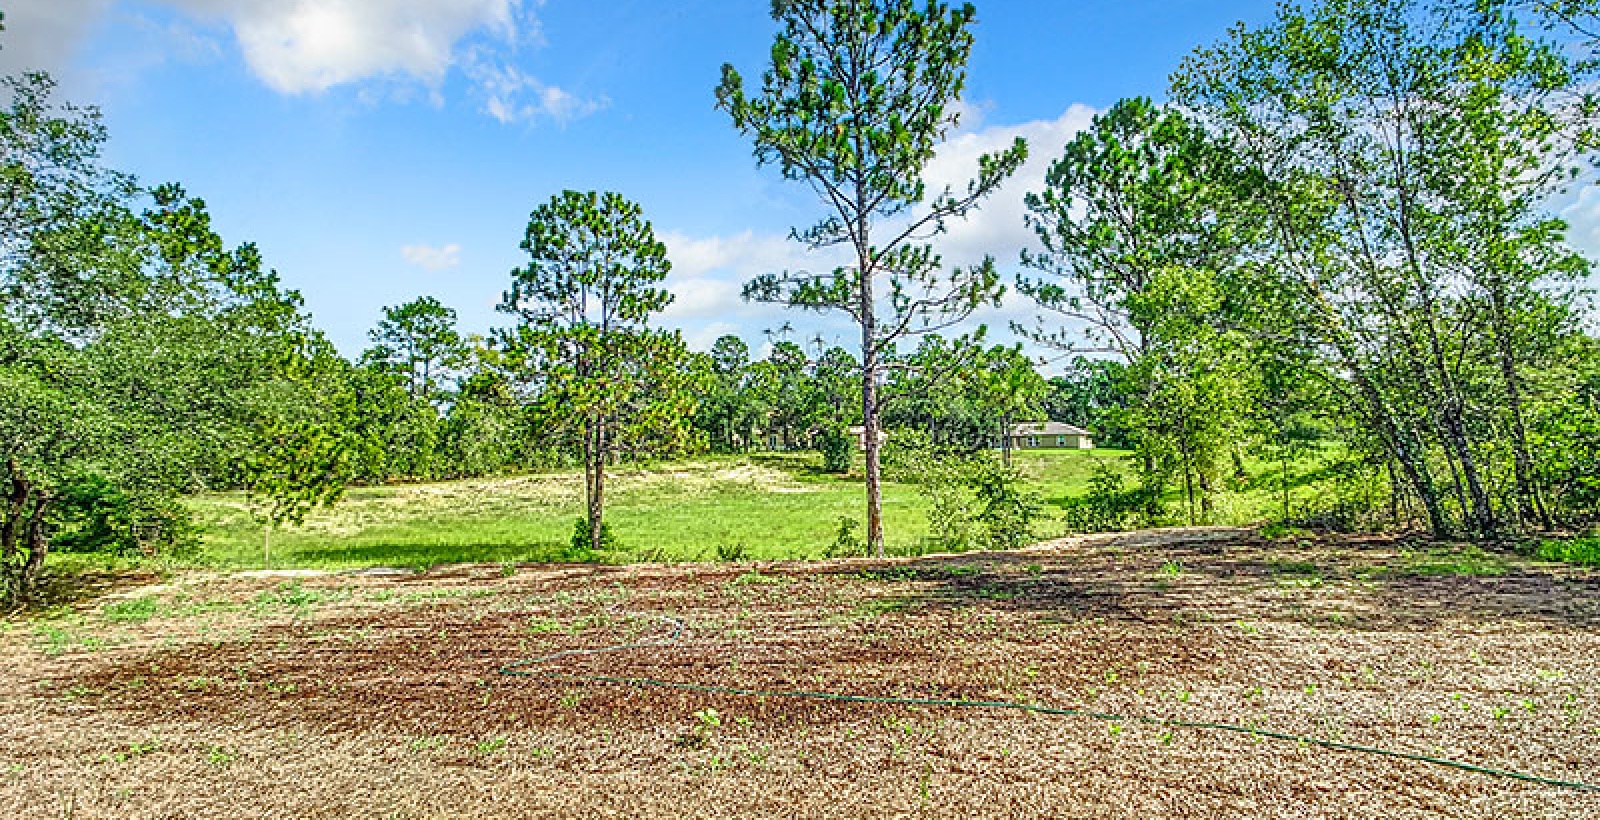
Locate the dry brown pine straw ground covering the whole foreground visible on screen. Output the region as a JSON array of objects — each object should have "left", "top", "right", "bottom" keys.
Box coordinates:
[{"left": 0, "top": 532, "right": 1600, "bottom": 820}]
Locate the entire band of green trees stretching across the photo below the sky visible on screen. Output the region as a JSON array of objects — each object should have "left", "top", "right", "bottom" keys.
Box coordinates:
[{"left": 0, "top": 0, "right": 1600, "bottom": 601}]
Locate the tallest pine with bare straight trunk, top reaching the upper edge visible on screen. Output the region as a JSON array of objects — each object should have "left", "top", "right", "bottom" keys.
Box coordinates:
[{"left": 717, "top": 0, "right": 1027, "bottom": 554}]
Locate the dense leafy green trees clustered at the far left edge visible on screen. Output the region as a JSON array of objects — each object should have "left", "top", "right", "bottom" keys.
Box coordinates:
[{"left": 0, "top": 75, "right": 347, "bottom": 602}]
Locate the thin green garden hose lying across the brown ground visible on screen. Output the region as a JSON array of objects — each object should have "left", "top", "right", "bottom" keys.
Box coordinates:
[{"left": 499, "top": 613, "right": 1600, "bottom": 791}]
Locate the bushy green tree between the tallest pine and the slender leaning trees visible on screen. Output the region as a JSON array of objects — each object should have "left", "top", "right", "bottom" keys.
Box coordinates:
[{"left": 1018, "top": 98, "right": 1253, "bottom": 524}]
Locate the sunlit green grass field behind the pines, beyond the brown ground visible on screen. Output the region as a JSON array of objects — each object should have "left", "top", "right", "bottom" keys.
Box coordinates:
[{"left": 192, "top": 450, "right": 1125, "bottom": 569}]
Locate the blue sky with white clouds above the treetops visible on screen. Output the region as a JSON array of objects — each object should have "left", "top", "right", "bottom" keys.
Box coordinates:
[{"left": 0, "top": 0, "right": 1600, "bottom": 365}]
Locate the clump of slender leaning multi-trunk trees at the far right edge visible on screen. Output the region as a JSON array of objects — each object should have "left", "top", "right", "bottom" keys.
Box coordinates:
[{"left": 1174, "top": 0, "right": 1595, "bottom": 535}]
